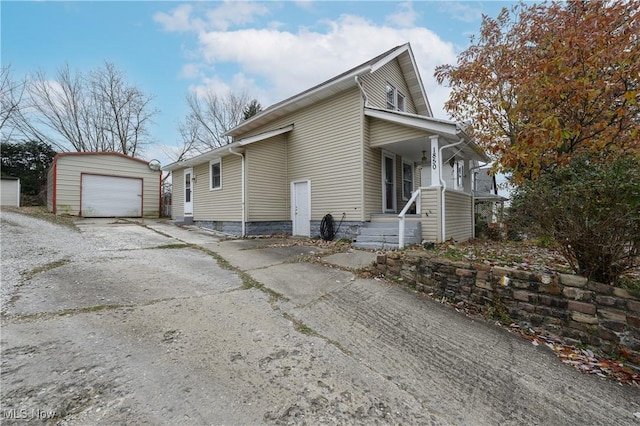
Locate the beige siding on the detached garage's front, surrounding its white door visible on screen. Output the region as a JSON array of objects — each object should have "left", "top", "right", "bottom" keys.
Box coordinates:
[{"left": 55, "top": 154, "right": 160, "bottom": 217}]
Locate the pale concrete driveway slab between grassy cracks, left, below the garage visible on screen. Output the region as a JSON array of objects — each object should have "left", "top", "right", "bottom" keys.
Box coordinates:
[{"left": 5, "top": 248, "right": 242, "bottom": 315}]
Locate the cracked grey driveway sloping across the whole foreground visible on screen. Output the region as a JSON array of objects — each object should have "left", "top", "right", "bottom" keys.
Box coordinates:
[{"left": 0, "top": 211, "right": 640, "bottom": 425}]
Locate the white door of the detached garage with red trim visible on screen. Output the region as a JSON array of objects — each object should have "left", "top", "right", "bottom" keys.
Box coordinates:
[{"left": 81, "top": 175, "right": 142, "bottom": 217}]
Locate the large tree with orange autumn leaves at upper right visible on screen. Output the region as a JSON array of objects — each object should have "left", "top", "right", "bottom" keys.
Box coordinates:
[{"left": 435, "top": 1, "right": 640, "bottom": 183}]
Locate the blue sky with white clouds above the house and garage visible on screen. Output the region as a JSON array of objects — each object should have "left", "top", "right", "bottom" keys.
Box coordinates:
[{"left": 0, "top": 0, "right": 514, "bottom": 165}]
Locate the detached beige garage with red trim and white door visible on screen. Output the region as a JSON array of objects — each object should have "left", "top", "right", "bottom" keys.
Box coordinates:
[{"left": 47, "top": 152, "right": 161, "bottom": 217}]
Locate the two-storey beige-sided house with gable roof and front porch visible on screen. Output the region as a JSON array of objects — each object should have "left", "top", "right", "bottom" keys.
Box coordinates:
[{"left": 164, "top": 44, "right": 489, "bottom": 248}]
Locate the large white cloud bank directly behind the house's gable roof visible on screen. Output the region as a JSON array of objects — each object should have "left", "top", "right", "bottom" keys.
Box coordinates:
[{"left": 156, "top": 3, "right": 456, "bottom": 118}]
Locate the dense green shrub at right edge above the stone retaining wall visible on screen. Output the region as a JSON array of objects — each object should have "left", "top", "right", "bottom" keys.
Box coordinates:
[{"left": 509, "top": 156, "right": 640, "bottom": 283}]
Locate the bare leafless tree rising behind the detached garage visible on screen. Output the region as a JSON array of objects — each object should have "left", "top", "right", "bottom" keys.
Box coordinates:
[{"left": 3, "top": 62, "right": 157, "bottom": 156}]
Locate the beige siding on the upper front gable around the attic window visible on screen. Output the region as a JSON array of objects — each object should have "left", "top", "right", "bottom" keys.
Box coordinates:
[{"left": 362, "top": 59, "right": 417, "bottom": 114}]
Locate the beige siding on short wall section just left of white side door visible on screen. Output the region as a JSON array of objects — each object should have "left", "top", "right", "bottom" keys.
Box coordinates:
[{"left": 246, "top": 134, "right": 291, "bottom": 222}]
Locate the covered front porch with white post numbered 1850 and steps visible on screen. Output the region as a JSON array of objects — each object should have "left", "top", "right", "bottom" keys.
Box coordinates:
[{"left": 365, "top": 108, "right": 489, "bottom": 248}]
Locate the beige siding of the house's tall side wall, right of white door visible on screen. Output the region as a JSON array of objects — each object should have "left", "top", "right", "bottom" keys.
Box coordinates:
[{"left": 236, "top": 88, "right": 362, "bottom": 220}]
